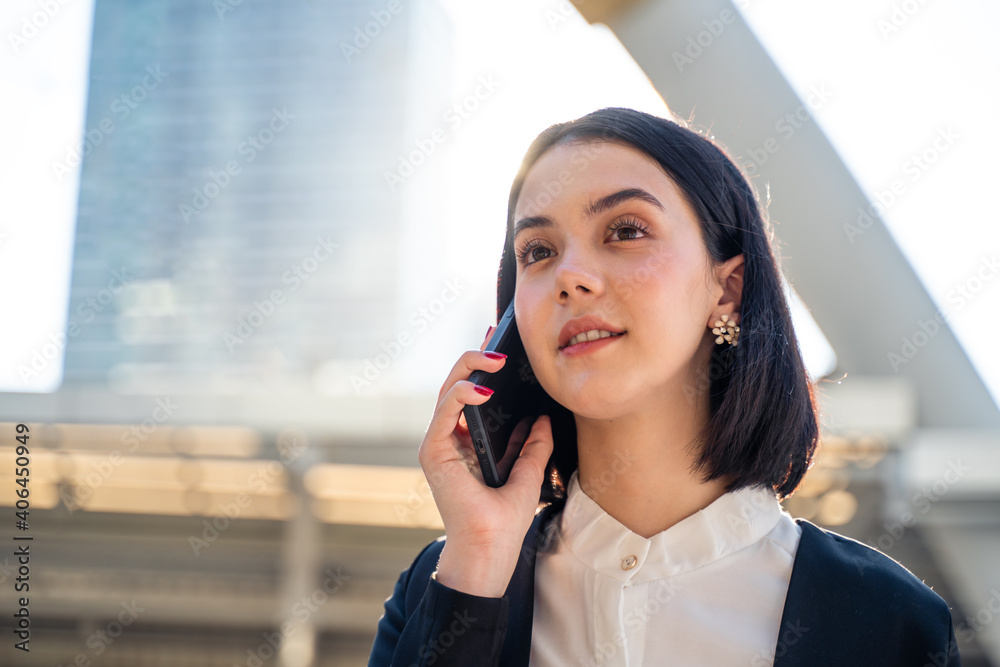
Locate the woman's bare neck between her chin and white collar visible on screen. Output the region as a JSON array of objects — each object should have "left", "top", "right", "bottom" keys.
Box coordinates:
[{"left": 576, "top": 378, "right": 732, "bottom": 539}]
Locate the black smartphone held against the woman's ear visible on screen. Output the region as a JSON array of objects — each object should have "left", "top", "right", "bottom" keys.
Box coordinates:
[{"left": 462, "top": 300, "right": 554, "bottom": 488}]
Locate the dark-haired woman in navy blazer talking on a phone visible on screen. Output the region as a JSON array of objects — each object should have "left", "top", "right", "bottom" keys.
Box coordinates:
[{"left": 369, "top": 108, "right": 960, "bottom": 667}]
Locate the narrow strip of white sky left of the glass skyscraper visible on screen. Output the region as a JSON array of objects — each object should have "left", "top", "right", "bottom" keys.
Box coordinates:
[{"left": 0, "top": 0, "right": 94, "bottom": 392}]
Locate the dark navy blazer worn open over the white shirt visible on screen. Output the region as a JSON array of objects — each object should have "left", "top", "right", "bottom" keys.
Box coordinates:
[{"left": 368, "top": 505, "right": 962, "bottom": 667}]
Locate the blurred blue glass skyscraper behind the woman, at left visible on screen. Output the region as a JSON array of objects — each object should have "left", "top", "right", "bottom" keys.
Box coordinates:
[{"left": 64, "top": 0, "right": 452, "bottom": 402}]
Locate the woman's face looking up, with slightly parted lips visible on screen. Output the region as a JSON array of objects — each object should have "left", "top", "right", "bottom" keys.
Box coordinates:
[{"left": 514, "top": 142, "right": 741, "bottom": 419}]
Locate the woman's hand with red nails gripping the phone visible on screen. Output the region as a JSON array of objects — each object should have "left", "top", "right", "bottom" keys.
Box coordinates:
[{"left": 417, "top": 328, "right": 553, "bottom": 597}]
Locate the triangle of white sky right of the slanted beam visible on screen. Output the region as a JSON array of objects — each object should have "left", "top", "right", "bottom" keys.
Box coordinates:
[{"left": 737, "top": 0, "right": 1000, "bottom": 403}]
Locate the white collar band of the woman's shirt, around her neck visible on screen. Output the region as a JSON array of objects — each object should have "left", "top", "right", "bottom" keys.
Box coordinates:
[{"left": 560, "top": 471, "right": 784, "bottom": 583}]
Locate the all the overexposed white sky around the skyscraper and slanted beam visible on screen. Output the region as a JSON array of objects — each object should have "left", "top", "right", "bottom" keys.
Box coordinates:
[{"left": 13, "top": 0, "right": 976, "bottom": 399}]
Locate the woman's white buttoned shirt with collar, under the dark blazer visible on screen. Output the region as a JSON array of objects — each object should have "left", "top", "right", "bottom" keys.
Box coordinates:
[{"left": 530, "top": 473, "right": 802, "bottom": 667}]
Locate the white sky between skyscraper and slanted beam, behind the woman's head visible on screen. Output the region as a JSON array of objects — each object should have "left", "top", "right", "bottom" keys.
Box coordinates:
[{"left": 390, "top": 0, "right": 835, "bottom": 393}]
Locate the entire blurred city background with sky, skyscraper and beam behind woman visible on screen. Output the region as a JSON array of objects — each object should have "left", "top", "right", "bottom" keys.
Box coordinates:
[{"left": 0, "top": 0, "right": 1000, "bottom": 667}]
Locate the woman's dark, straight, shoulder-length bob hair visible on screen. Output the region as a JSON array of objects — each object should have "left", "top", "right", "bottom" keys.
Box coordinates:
[{"left": 497, "top": 108, "right": 819, "bottom": 506}]
